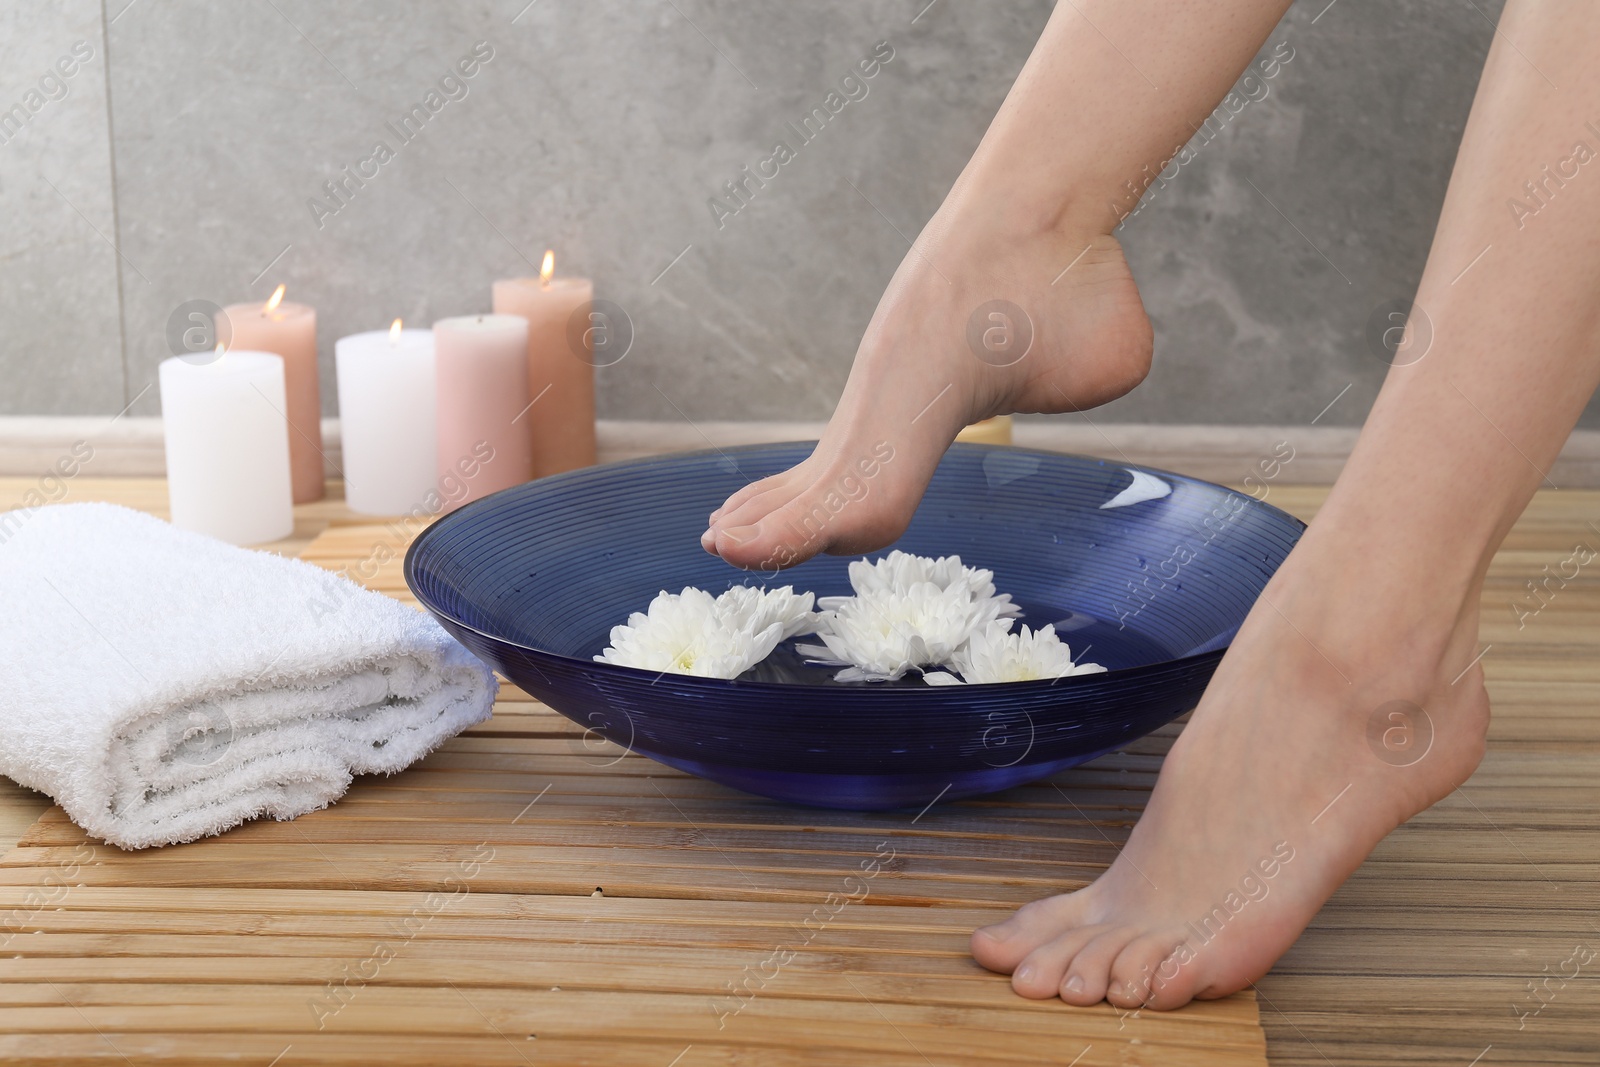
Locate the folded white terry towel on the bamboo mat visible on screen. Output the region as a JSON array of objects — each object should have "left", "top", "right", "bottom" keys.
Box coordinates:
[{"left": 0, "top": 504, "right": 496, "bottom": 849}]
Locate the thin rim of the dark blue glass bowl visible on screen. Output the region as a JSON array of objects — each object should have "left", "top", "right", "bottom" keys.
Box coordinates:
[{"left": 402, "top": 440, "right": 1307, "bottom": 701}]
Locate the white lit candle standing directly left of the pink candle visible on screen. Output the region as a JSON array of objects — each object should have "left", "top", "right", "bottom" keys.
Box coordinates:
[{"left": 333, "top": 318, "right": 438, "bottom": 515}]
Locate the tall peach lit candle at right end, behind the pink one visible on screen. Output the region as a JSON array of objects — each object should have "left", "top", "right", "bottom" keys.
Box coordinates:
[{"left": 494, "top": 251, "right": 595, "bottom": 478}]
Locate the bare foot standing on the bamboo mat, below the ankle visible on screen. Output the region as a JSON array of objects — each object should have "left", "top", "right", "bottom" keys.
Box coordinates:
[{"left": 971, "top": 557, "right": 1488, "bottom": 1009}]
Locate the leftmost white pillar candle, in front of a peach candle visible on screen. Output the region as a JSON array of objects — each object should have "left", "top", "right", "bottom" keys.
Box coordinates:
[{"left": 160, "top": 352, "right": 294, "bottom": 544}]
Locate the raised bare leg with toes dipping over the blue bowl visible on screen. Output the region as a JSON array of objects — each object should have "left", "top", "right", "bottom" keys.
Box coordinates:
[{"left": 702, "top": 0, "right": 1288, "bottom": 568}]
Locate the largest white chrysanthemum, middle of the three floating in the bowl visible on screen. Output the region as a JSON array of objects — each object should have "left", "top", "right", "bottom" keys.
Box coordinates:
[{"left": 800, "top": 552, "right": 1019, "bottom": 681}]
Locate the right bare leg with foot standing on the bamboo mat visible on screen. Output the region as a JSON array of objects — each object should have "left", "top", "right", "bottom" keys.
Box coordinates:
[{"left": 973, "top": 0, "right": 1600, "bottom": 1008}]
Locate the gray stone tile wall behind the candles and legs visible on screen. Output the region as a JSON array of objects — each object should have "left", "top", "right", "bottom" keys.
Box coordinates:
[{"left": 0, "top": 0, "right": 1600, "bottom": 426}]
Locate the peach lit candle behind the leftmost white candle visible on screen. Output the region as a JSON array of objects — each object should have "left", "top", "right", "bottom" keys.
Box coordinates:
[{"left": 222, "top": 285, "right": 323, "bottom": 504}]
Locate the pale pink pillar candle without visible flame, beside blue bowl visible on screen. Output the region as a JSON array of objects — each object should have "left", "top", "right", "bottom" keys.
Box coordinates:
[{"left": 434, "top": 315, "right": 533, "bottom": 509}]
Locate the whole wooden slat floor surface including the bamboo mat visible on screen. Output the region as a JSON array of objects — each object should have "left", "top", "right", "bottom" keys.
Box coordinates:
[{"left": 0, "top": 478, "right": 1600, "bottom": 1067}]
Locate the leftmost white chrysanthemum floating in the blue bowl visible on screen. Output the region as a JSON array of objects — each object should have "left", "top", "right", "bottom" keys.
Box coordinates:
[{"left": 595, "top": 585, "right": 816, "bottom": 678}]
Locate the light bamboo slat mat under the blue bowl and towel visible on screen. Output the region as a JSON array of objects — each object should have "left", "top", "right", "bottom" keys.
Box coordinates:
[{"left": 0, "top": 511, "right": 1266, "bottom": 1067}]
